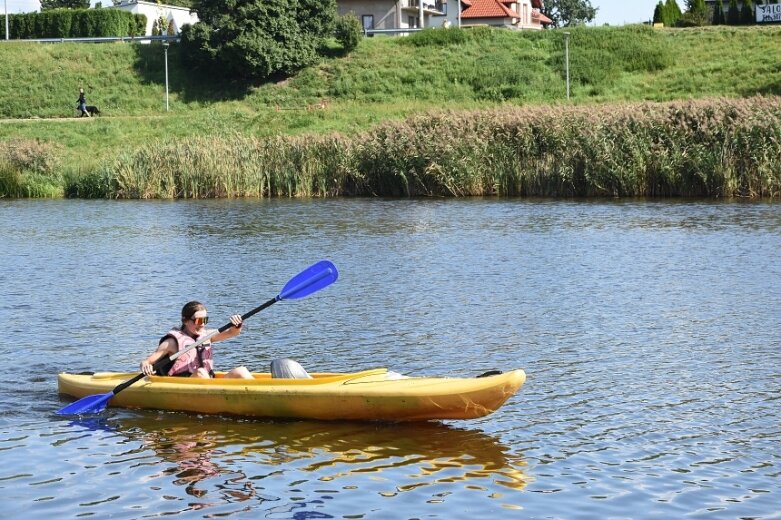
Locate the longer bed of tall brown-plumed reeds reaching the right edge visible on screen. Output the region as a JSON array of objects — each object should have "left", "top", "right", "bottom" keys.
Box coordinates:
[{"left": 66, "top": 97, "right": 781, "bottom": 199}]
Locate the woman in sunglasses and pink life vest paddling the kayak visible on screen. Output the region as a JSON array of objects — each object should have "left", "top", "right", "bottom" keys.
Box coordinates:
[{"left": 141, "top": 301, "right": 252, "bottom": 379}]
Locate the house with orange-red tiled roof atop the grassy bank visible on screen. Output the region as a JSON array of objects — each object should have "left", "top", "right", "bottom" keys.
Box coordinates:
[{"left": 461, "top": 0, "right": 552, "bottom": 31}]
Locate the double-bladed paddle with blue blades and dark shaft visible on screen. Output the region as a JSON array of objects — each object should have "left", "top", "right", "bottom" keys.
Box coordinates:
[{"left": 57, "top": 260, "right": 339, "bottom": 415}]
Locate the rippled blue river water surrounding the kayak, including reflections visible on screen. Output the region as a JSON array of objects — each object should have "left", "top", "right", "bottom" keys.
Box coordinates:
[{"left": 0, "top": 199, "right": 781, "bottom": 519}]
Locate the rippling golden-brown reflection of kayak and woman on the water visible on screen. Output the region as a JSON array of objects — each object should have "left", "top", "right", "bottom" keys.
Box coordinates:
[{"left": 106, "top": 412, "right": 527, "bottom": 508}]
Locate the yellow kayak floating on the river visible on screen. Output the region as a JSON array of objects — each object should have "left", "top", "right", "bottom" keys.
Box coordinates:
[{"left": 57, "top": 368, "right": 526, "bottom": 421}]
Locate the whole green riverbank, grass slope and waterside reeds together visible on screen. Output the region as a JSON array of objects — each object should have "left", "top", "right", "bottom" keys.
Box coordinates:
[{"left": 0, "top": 22, "right": 781, "bottom": 197}]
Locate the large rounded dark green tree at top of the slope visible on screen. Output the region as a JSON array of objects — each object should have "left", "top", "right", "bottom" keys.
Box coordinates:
[{"left": 181, "top": 0, "right": 336, "bottom": 79}]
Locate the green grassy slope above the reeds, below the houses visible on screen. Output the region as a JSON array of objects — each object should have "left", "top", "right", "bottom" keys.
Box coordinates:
[{"left": 0, "top": 26, "right": 781, "bottom": 169}]
